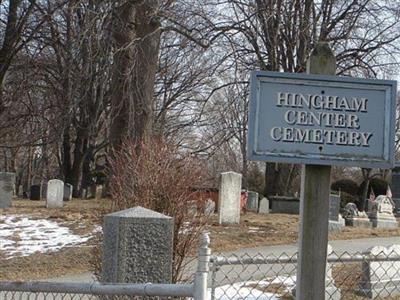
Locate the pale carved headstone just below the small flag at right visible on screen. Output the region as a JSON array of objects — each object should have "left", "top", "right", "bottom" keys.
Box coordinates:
[{"left": 368, "top": 195, "right": 398, "bottom": 228}]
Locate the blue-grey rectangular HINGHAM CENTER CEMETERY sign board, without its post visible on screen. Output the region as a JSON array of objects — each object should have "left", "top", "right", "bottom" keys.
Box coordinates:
[{"left": 248, "top": 71, "right": 396, "bottom": 168}]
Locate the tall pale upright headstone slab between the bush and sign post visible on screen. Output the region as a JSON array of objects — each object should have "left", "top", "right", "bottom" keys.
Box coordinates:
[{"left": 218, "top": 172, "right": 242, "bottom": 224}]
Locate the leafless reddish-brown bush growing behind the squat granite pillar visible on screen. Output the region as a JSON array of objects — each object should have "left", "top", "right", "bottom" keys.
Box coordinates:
[{"left": 110, "top": 139, "right": 211, "bottom": 282}]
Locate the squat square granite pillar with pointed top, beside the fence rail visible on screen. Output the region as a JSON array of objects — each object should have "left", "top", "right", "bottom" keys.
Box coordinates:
[{"left": 102, "top": 206, "right": 174, "bottom": 283}]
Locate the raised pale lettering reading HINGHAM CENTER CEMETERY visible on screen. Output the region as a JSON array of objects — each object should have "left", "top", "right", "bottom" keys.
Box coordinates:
[{"left": 270, "top": 92, "right": 373, "bottom": 147}]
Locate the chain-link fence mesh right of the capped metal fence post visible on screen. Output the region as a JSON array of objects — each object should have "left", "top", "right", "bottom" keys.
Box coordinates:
[{"left": 210, "top": 247, "right": 400, "bottom": 300}]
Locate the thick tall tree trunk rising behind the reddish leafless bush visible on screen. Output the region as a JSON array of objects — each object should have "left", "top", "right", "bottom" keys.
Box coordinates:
[{"left": 110, "top": 0, "right": 160, "bottom": 148}]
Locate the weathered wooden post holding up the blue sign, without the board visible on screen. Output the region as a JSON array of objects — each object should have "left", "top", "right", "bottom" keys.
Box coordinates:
[{"left": 296, "top": 43, "right": 336, "bottom": 300}]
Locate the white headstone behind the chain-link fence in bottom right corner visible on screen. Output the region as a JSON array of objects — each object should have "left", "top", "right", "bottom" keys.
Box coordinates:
[{"left": 359, "top": 245, "right": 400, "bottom": 299}]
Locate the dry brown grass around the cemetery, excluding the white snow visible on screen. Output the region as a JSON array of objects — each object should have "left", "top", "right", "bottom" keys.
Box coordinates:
[{"left": 0, "top": 199, "right": 400, "bottom": 282}]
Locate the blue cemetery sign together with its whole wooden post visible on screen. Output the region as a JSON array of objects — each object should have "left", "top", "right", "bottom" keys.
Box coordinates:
[{"left": 248, "top": 43, "right": 397, "bottom": 300}]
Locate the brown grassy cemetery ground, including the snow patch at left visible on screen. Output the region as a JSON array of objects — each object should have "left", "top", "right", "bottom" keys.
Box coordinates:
[{"left": 0, "top": 199, "right": 400, "bottom": 280}]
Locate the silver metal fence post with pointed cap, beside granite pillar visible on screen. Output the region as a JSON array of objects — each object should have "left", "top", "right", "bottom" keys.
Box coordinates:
[{"left": 193, "top": 232, "right": 211, "bottom": 300}]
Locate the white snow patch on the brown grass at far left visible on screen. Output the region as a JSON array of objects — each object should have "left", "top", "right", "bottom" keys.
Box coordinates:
[{"left": 0, "top": 215, "right": 98, "bottom": 259}]
